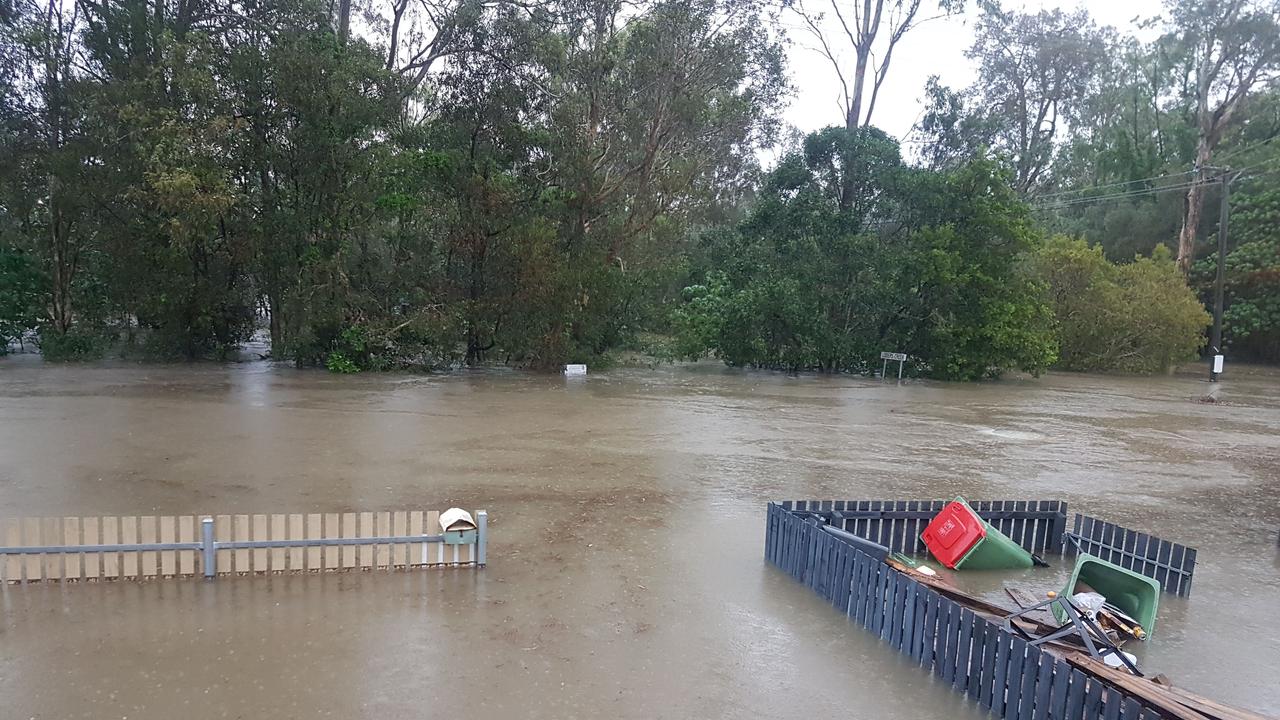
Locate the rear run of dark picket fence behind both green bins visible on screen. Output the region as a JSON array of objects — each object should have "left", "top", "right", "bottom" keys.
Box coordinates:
[{"left": 781, "top": 500, "right": 1196, "bottom": 596}]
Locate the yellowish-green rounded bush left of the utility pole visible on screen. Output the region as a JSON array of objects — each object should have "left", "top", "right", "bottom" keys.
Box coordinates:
[{"left": 1030, "top": 236, "right": 1210, "bottom": 373}]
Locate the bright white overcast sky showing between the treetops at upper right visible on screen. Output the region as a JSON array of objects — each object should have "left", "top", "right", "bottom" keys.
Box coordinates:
[{"left": 782, "top": 0, "right": 1161, "bottom": 138}]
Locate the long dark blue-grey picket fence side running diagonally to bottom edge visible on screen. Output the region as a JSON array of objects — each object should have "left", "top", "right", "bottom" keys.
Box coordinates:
[{"left": 764, "top": 502, "right": 1162, "bottom": 720}]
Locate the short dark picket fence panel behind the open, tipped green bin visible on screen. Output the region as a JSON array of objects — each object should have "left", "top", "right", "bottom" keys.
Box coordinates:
[{"left": 1062, "top": 512, "right": 1196, "bottom": 597}]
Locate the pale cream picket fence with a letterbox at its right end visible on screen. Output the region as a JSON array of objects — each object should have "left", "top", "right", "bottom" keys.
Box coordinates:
[{"left": 0, "top": 510, "right": 488, "bottom": 583}]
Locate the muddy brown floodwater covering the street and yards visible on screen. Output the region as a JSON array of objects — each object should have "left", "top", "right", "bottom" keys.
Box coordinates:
[{"left": 0, "top": 356, "right": 1280, "bottom": 720}]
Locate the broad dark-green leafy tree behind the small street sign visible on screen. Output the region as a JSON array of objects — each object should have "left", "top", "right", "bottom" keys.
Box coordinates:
[{"left": 672, "top": 128, "right": 1053, "bottom": 379}]
